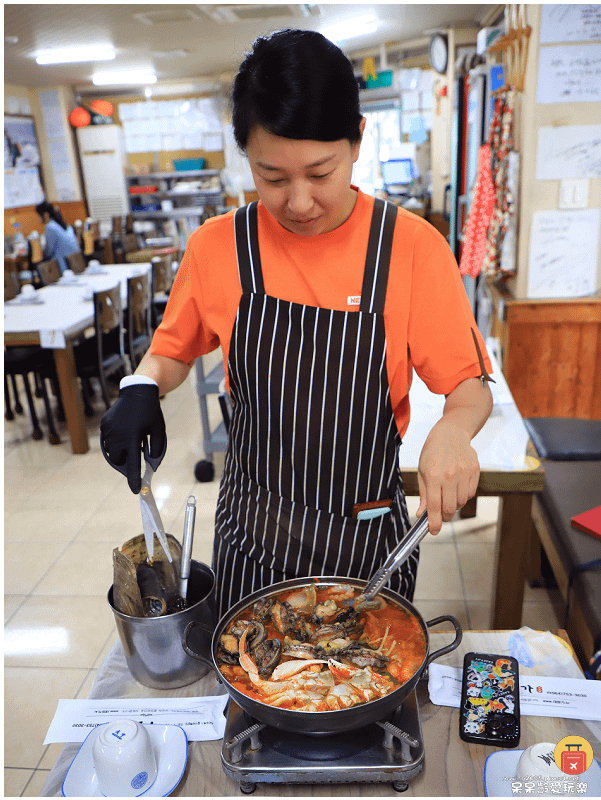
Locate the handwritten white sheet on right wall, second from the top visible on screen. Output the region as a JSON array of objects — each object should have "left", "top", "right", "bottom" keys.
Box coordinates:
[{"left": 536, "top": 44, "right": 601, "bottom": 103}]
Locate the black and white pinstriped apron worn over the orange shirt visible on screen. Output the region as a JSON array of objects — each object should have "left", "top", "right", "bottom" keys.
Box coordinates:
[{"left": 213, "top": 200, "right": 418, "bottom": 616}]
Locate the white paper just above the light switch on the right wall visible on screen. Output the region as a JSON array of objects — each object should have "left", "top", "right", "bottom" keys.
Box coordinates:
[{"left": 536, "top": 125, "right": 601, "bottom": 181}]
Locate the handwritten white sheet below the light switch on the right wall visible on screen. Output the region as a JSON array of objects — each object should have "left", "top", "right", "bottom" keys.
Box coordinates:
[{"left": 527, "top": 208, "right": 601, "bottom": 298}]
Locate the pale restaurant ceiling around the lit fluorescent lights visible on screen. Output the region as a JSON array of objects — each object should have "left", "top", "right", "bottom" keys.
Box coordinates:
[{"left": 4, "top": 3, "right": 503, "bottom": 87}]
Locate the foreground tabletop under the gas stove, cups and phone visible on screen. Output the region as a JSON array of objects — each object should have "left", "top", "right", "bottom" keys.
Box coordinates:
[{"left": 40, "top": 628, "right": 601, "bottom": 798}]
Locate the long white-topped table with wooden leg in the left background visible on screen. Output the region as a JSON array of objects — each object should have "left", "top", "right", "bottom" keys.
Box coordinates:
[{"left": 4, "top": 263, "right": 151, "bottom": 453}]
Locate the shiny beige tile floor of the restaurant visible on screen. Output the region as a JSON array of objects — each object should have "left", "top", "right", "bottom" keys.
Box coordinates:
[{"left": 4, "top": 354, "right": 561, "bottom": 797}]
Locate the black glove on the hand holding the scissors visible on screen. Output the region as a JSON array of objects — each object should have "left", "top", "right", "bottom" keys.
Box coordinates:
[{"left": 100, "top": 383, "right": 167, "bottom": 494}]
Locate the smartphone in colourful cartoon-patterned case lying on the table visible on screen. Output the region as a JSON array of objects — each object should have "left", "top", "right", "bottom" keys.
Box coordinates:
[{"left": 459, "top": 653, "right": 520, "bottom": 747}]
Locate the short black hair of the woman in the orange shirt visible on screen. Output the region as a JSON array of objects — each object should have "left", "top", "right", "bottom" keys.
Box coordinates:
[{"left": 231, "top": 29, "right": 361, "bottom": 150}]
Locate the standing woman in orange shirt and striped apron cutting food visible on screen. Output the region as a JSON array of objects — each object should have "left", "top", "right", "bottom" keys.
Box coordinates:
[{"left": 101, "top": 31, "right": 492, "bottom": 613}]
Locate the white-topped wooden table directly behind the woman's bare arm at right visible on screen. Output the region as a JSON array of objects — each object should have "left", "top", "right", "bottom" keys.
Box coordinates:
[{"left": 399, "top": 355, "right": 545, "bottom": 630}]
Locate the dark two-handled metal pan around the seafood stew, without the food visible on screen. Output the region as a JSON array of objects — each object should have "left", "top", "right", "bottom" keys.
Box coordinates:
[{"left": 183, "top": 576, "right": 463, "bottom": 736}]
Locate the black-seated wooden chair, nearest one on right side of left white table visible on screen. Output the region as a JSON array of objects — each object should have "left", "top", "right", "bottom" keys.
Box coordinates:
[{"left": 75, "top": 286, "right": 127, "bottom": 416}]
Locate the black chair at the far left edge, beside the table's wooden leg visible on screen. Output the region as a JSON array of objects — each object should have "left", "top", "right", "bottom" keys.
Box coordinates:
[{"left": 4, "top": 346, "right": 60, "bottom": 444}]
